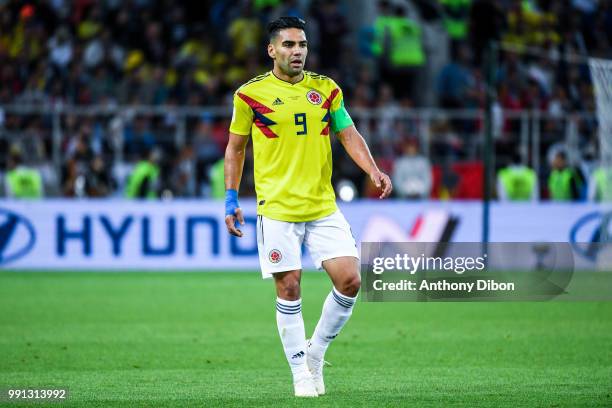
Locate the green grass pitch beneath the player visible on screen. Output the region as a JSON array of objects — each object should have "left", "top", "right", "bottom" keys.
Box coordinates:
[{"left": 0, "top": 272, "right": 612, "bottom": 407}]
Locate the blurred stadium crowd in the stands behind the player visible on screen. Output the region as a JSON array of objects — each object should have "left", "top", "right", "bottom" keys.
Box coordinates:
[{"left": 0, "top": 0, "right": 612, "bottom": 200}]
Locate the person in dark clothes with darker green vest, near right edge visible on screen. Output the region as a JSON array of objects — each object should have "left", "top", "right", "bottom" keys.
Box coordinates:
[{"left": 548, "top": 151, "right": 584, "bottom": 201}]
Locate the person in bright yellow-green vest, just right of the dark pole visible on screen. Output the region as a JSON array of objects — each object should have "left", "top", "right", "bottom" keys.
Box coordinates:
[{"left": 497, "top": 155, "right": 540, "bottom": 201}]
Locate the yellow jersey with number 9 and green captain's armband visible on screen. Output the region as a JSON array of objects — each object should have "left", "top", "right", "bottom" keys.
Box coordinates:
[{"left": 230, "top": 71, "right": 353, "bottom": 222}]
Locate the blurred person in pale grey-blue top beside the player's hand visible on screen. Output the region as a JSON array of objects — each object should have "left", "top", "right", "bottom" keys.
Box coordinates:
[{"left": 392, "top": 139, "right": 432, "bottom": 199}]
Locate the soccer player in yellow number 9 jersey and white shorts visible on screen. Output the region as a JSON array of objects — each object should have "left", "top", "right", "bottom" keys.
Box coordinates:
[{"left": 225, "top": 17, "right": 392, "bottom": 397}]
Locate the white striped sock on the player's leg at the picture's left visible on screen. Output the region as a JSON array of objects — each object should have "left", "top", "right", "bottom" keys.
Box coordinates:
[{"left": 276, "top": 297, "right": 308, "bottom": 379}]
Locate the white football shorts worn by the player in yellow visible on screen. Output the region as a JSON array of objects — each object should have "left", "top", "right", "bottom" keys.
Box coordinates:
[{"left": 257, "top": 210, "right": 359, "bottom": 279}]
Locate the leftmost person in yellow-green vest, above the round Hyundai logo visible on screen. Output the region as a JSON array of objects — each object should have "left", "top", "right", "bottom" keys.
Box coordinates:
[{"left": 4, "top": 150, "right": 44, "bottom": 199}]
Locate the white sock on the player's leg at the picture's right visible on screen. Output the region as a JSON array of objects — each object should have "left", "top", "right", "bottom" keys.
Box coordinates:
[{"left": 308, "top": 288, "right": 357, "bottom": 360}]
